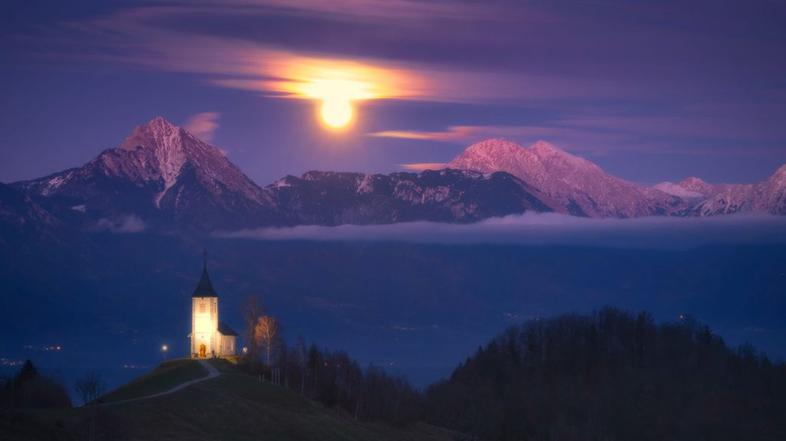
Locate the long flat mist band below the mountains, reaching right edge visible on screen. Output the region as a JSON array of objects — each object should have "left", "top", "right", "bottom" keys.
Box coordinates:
[{"left": 220, "top": 213, "right": 786, "bottom": 249}]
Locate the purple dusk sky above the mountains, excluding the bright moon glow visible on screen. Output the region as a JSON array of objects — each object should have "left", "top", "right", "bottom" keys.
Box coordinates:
[{"left": 0, "top": 0, "right": 786, "bottom": 185}]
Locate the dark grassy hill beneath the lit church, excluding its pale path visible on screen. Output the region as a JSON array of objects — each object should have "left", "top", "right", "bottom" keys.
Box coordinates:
[{"left": 0, "top": 360, "right": 455, "bottom": 441}]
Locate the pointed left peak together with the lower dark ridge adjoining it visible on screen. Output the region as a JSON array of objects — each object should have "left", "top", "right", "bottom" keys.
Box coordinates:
[{"left": 14, "top": 117, "right": 553, "bottom": 231}]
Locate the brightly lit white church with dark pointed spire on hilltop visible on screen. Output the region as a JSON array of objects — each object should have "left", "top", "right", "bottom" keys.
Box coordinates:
[{"left": 189, "top": 259, "right": 237, "bottom": 358}]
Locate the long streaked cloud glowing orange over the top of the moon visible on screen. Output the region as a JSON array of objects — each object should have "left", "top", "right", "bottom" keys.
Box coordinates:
[{"left": 38, "top": 4, "right": 641, "bottom": 107}]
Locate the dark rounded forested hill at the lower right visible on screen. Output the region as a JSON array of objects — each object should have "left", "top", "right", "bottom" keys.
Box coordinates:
[{"left": 425, "top": 309, "right": 786, "bottom": 441}]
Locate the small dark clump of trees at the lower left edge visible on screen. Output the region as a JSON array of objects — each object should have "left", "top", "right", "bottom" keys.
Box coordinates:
[{"left": 0, "top": 360, "right": 71, "bottom": 409}]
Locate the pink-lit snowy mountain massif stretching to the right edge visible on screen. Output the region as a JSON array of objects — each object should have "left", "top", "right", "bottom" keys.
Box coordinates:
[{"left": 448, "top": 139, "right": 786, "bottom": 218}]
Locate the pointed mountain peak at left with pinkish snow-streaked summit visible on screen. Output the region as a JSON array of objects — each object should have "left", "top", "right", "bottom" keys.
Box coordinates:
[{"left": 15, "top": 117, "right": 276, "bottom": 229}]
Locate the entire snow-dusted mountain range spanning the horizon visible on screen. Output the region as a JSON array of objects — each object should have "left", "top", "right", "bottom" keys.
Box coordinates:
[{"left": 0, "top": 117, "right": 786, "bottom": 234}]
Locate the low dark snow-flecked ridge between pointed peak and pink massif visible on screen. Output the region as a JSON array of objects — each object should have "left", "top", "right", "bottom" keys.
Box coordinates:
[{"left": 265, "top": 170, "right": 552, "bottom": 225}]
